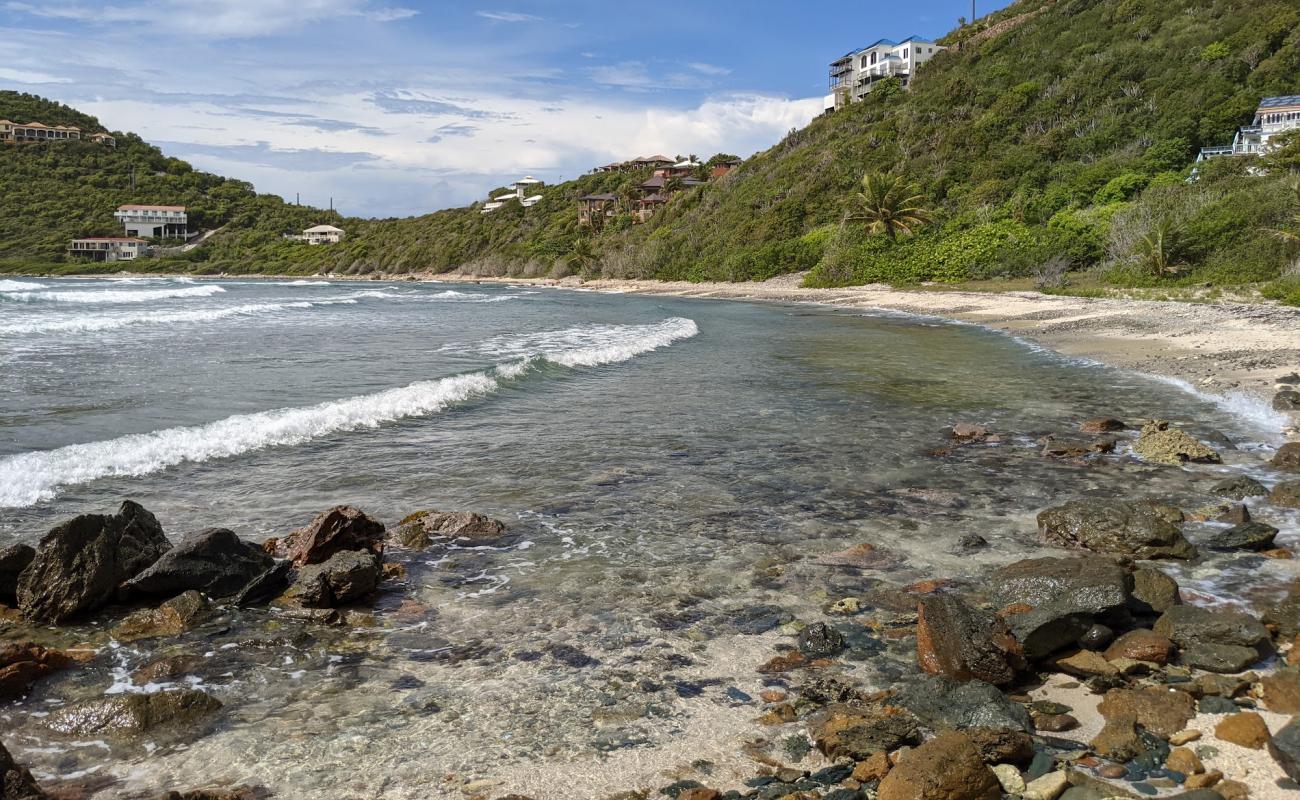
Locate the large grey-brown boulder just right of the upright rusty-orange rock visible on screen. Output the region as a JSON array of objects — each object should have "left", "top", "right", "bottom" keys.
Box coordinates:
[{"left": 989, "top": 558, "right": 1132, "bottom": 661}]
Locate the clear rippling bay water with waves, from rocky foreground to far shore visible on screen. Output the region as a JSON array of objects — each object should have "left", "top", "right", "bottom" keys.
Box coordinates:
[{"left": 0, "top": 278, "right": 1297, "bottom": 797}]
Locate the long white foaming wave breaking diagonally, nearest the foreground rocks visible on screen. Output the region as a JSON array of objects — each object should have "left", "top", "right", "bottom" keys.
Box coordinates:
[{"left": 0, "top": 317, "right": 699, "bottom": 509}]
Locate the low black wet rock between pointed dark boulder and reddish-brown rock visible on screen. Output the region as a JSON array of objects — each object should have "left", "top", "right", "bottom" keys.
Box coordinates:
[{"left": 122, "top": 528, "right": 276, "bottom": 597}]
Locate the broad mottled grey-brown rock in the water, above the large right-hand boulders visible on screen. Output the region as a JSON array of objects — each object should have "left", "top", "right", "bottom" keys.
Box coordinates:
[{"left": 1039, "top": 500, "right": 1196, "bottom": 558}]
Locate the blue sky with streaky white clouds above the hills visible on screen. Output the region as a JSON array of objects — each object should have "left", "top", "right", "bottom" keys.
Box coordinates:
[{"left": 0, "top": 0, "right": 1009, "bottom": 217}]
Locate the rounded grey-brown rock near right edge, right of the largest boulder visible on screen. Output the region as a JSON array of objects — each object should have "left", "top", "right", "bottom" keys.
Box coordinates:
[{"left": 1154, "top": 606, "right": 1269, "bottom": 673}]
